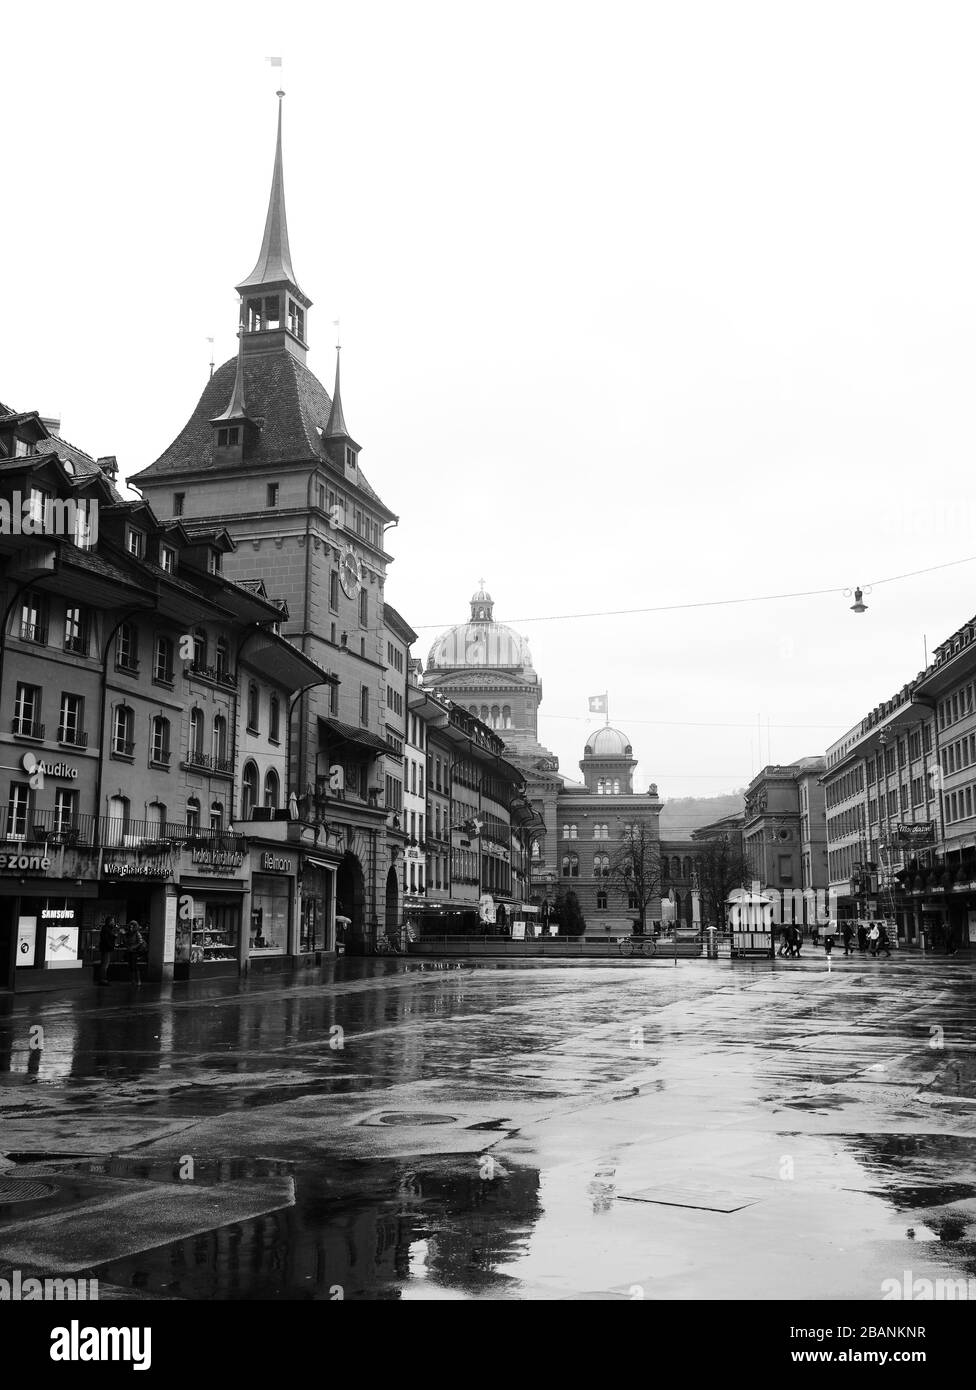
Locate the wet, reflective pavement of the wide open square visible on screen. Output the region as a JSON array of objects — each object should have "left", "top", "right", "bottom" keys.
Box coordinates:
[{"left": 0, "top": 955, "right": 976, "bottom": 1300}]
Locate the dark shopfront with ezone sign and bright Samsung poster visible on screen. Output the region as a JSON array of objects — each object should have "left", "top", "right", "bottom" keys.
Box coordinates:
[{"left": 0, "top": 847, "right": 99, "bottom": 992}]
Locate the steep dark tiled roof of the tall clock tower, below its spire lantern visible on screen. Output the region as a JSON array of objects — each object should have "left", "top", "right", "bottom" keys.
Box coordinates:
[{"left": 129, "top": 348, "right": 393, "bottom": 516}]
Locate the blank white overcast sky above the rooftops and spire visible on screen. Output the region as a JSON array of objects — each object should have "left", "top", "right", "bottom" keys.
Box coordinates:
[{"left": 0, "top": 0, "right": 976, "bottom": 796}]
